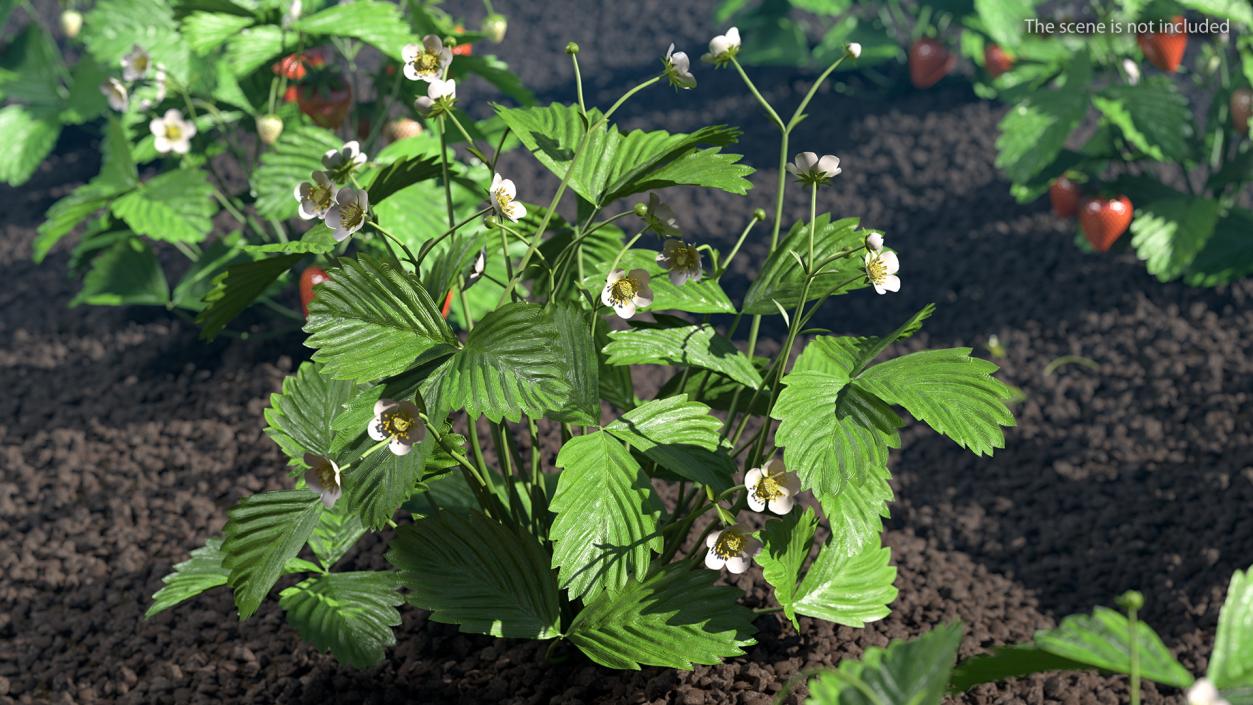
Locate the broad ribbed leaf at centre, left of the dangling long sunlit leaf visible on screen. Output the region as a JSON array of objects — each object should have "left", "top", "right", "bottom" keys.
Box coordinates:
[{"left": 423, "top": 301, "right": 570, "bottom": 423}]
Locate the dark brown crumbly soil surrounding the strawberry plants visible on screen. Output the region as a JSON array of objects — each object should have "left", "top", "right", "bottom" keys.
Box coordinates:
[{"left": 0, "top": 0, "right": 1253, "bottom": 705}]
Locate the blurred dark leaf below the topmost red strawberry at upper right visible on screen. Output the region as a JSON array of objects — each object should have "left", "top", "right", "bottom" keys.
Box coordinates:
[{"left": 1093, "top": 75, "right": 1193, "bottom": 162}]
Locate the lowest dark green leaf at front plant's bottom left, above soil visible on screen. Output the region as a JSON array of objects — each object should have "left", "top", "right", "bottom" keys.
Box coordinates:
[{"left": 278, "top": 571, "right": 405, "bottom": 669}]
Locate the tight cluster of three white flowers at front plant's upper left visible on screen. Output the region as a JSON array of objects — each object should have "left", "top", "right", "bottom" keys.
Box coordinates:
[{"left": 292, "top": 140, "right": 370, "bottom": 242}]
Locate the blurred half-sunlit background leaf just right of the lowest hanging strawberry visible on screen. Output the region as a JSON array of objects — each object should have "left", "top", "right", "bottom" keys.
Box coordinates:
[{"left": 1131, "top": 195, "right": 1219, "bottom": 282}]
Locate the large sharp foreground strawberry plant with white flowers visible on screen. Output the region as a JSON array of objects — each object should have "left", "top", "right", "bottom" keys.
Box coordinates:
[{"left": 132, "top": 20, "right": 1014, "bottom": 669}]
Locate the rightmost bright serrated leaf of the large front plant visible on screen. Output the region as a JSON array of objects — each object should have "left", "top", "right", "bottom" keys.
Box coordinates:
[{"left": 853, "top": 348, "right": 1014, "bottom": 456}]
